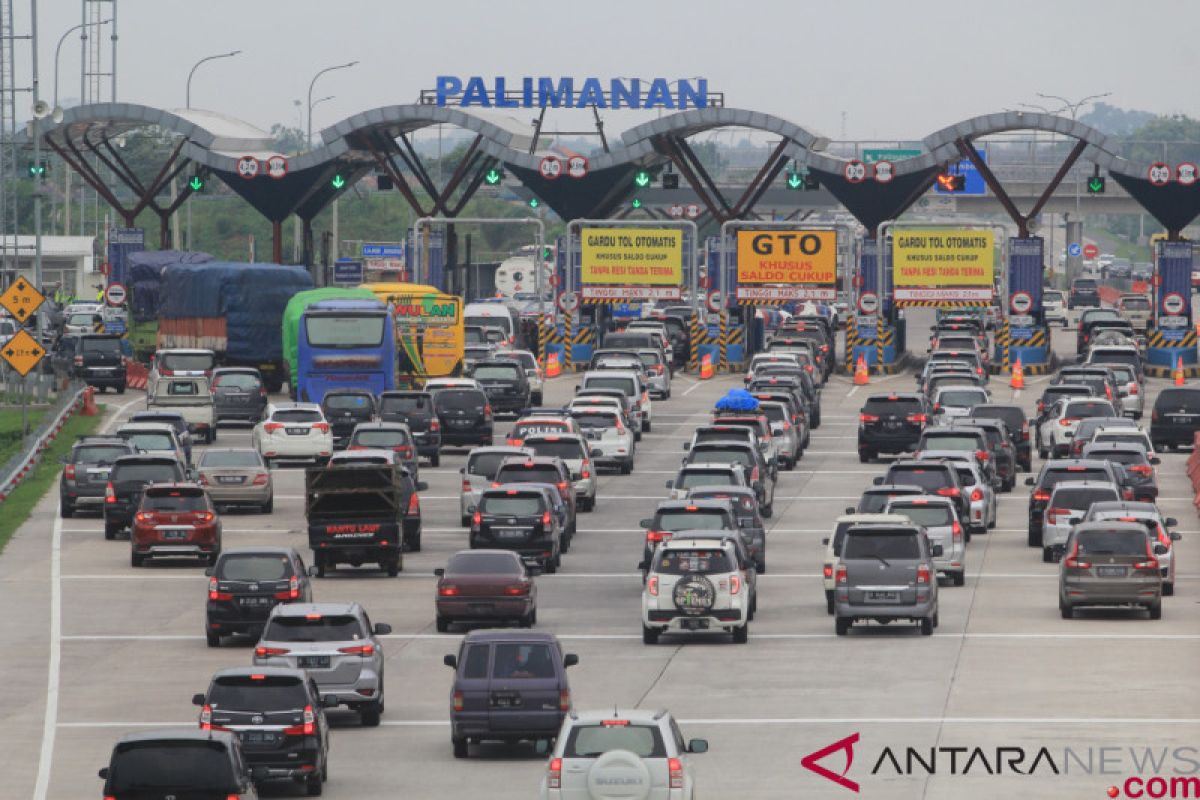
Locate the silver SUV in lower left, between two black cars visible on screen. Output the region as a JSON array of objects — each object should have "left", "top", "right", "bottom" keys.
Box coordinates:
[{"left": 253, "top": 603, "right": 391, "bottom": 727}]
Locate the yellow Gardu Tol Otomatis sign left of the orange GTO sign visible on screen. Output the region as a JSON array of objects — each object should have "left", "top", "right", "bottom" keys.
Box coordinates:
[{"left": 580, "top": 228, "right": 683, "bottom": 287}]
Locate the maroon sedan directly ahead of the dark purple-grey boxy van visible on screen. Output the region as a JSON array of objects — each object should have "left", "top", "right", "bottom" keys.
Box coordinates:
[{"left": 433, "top": 549, "right": 538, "bottom": 633}]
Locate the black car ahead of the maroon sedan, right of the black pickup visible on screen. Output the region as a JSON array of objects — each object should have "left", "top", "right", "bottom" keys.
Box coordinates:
[{"left": 467, "top": 486, "right": 564, "bottom": 573}]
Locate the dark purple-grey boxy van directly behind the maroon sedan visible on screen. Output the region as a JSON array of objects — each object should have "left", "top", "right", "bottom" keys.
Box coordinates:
[{"left": 442, "top": 631, "right": 580, "bottom": 758}]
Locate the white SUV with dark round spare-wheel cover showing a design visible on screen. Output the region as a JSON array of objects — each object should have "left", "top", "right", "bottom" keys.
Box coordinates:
[{"left": 642, "top": 531, "right": 755, "bottom": 644}]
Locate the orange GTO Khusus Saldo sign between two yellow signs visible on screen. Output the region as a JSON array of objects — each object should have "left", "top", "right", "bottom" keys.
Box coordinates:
[{"left": 738, "top": 230, "right": 838, "bottom": 285}]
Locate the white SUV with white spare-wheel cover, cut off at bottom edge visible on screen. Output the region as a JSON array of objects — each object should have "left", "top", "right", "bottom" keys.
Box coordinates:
[{"left": 539, "top": 708, "right": 708, "bottom": 800}]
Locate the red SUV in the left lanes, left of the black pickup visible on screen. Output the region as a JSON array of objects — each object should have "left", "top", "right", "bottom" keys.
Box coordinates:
[{"left": 130, "top": 483, "right": 221, "bottom": 566}]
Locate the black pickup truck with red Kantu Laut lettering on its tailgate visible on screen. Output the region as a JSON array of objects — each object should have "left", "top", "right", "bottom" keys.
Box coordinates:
[{"left": 305, "top": 464, "right": 424, "bottom": 577}]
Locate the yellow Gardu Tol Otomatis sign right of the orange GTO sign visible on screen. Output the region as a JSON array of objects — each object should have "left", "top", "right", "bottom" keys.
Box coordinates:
[{"left": 892, "top": 228, "right": 996, "bottom": 289}]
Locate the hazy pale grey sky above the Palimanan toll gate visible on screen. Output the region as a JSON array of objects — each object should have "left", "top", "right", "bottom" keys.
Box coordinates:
[{"left": 13, "top": 0, "right": 1200, "bottom": 139}]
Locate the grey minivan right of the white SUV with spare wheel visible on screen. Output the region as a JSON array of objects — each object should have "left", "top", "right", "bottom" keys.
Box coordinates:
[{"left": 834, "top": 523, "right": 942, "bottom": 636}]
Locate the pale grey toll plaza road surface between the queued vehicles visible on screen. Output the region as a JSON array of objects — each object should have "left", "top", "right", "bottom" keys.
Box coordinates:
[{"left": 0, "top": 320, "right": 1200, "bottom": 800}]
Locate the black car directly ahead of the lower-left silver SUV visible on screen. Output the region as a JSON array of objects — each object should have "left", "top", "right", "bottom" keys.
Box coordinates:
[{"left": 204, "top": 547, "right": 312, "bottom": 648}]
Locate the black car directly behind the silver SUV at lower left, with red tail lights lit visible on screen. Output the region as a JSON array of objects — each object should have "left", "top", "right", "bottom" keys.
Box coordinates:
[{"left": 193, "top": 667, "right": 337, "bottom": 796}]
